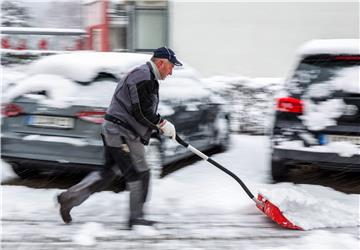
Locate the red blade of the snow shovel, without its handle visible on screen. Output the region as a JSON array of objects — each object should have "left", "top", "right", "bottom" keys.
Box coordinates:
[{"left": 256, "top": 194, "right": 304, "bottom": 230}]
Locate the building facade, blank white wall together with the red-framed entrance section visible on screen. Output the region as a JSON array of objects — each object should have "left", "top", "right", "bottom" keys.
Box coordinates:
[{"left": 83, "top": 0, "right": 360, "bottom": 77}]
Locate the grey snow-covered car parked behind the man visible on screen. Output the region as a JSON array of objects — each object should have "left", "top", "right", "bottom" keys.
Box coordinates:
[{"left": 1, "top": 51, "right": 229, "bottom": 178}]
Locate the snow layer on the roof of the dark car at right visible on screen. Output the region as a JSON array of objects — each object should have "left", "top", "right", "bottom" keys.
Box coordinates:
[{"left": 298, "top": 39, "right": 360, "bottom": 55}]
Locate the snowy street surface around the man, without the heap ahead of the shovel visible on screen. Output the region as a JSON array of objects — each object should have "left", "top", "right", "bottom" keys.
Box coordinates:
[{"left": 1, "top": 135, "right": 359, "bottom": 250}]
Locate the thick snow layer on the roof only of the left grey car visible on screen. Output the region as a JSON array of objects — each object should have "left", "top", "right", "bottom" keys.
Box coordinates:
[{"left": 29, "top": 51, "right": 197, "bottom": 82}]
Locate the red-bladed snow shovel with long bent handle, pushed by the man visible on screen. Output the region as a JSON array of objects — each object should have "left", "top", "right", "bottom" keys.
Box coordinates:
[{"left": 175, "top": 135, "right": 303, "bottom": 230}]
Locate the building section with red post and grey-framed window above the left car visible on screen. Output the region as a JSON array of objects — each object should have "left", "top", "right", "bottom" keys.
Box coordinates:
[{"left": 83, "top": 0, "right": 169, "bottom": 52}]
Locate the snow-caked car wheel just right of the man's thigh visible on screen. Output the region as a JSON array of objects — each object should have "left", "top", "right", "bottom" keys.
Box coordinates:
[{"left": 145, "top": 139, "right": 163, "bottom": 179}]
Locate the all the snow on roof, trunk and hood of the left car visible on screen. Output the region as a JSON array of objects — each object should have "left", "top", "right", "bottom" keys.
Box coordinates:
[{"left": 2, "top": 51, "right": 210, "bottom": 108}]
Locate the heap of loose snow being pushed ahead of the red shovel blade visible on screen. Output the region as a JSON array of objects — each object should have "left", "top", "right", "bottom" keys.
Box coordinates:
[{"left": 260, "top": 183, "right": 360, "bottom": 230}]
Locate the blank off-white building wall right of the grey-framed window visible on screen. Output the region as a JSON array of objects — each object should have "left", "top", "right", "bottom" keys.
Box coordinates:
[{"left": 169, "top": 0, "right": 360, "bottom": 77}]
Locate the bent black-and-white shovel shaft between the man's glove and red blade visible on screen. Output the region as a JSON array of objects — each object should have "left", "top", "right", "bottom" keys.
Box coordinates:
[{"left": 175, "top": 135, "right": 257, "bottom": 200}]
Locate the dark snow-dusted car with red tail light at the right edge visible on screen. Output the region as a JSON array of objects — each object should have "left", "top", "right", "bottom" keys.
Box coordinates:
[{"left": 271, "top": 39, "right": 360, "bottom": 181}]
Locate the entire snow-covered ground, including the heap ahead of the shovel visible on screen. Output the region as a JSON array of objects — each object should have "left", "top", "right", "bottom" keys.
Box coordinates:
[{"left": 1, "top": 135, "right": 360, "bottom": 249}]
